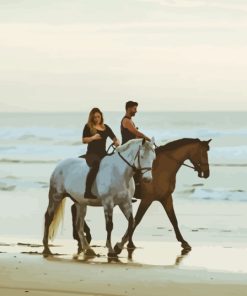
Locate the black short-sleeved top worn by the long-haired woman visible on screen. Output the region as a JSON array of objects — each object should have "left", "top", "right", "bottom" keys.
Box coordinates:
[{"left": 82, "top": 124, "right": 116, "bottom": 157}]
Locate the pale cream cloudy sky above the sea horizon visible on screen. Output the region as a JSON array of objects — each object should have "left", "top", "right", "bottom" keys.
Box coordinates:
[{"left": 0, "top": 0, "right": 247, "bottom": 112}]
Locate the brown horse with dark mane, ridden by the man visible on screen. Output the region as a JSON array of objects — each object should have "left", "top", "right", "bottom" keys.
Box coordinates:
[{"left": 72, "top": 138, "right": 211, "bottom": 254}]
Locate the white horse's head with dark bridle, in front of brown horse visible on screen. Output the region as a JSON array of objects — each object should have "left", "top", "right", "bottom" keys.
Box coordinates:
[{"left": 134, "top": 138, "right": 156, "bottom": 182}]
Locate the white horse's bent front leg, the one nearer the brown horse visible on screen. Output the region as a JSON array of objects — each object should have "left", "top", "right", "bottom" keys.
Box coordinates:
[{"left": 114, "top": 200, "right": 134, "bottom": 254}]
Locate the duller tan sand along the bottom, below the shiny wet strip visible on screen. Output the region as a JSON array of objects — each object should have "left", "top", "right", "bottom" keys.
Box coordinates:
[{"left": 0, "top": 246, "right": 247, "bottom": 296}]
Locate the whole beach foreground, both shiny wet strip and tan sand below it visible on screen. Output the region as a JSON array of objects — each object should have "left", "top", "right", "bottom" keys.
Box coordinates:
[{"left": 0, "top": 240, "right": 247, "bottom": 296}]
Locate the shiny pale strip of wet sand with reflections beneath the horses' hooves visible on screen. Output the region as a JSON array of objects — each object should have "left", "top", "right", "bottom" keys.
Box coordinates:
[{"left": 0, "top": 241, "right": 247, "bottom": 273}]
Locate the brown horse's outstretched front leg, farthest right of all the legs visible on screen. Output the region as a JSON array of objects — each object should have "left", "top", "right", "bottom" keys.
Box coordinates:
[{"left": 160, "top": 195, "right": 191, "bottom": 250}]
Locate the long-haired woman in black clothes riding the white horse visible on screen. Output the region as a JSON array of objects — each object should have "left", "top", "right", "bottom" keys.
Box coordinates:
[{"left": 82, "top": 108, "right": 120, "bottom": 198}]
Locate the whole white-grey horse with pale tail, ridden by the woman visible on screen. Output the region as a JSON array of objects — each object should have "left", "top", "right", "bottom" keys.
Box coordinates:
[{"left": 43, "top": 139, "right": 155, "bottom": 257}]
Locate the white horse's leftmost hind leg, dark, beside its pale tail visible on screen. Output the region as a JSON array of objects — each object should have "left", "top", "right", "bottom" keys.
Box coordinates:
[{"left": 43, "top": 189, "right": 64, "bottom": 254}]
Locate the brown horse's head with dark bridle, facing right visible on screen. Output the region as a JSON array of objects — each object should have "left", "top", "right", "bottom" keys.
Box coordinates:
[{"left": 190, "top": 139, "right": 211, "bottom": 178}]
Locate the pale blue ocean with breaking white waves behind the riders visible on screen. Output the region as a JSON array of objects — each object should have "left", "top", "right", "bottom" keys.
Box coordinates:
[{"left": 0, "top": 112, "right": 247, "bottom": 194}]
